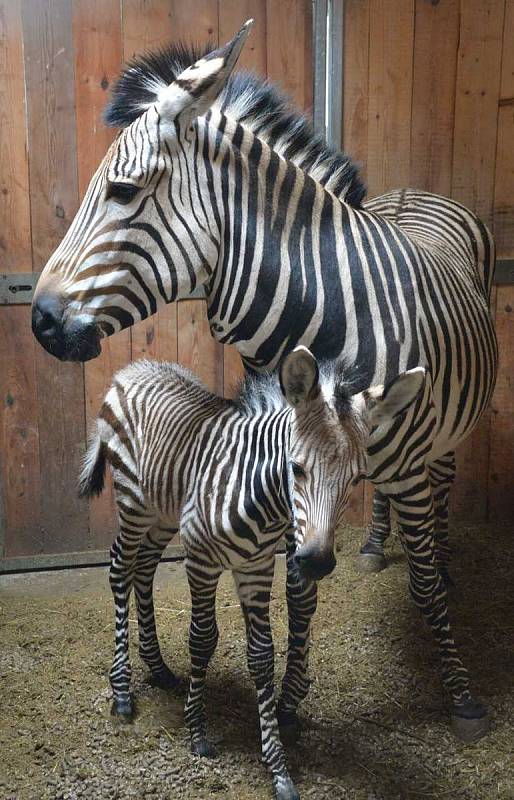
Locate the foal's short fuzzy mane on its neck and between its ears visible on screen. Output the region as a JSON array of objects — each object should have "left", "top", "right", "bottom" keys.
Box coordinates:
[{"left": 234, "top": 359, "right": 353, "bottom": 418}]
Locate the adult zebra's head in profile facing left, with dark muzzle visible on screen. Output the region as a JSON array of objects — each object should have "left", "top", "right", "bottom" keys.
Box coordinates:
[{"left": 32, "top": 20, "right": 253, "bottom": 361}]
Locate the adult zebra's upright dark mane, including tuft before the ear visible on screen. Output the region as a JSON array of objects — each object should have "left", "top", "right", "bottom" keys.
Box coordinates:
[{"left": 104, "top": 43, "right": 365, "bottom": 208}]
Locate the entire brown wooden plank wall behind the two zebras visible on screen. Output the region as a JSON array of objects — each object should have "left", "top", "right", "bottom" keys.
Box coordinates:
[{"left": 0, "top": 0, "right": 508, "bottom": 556}]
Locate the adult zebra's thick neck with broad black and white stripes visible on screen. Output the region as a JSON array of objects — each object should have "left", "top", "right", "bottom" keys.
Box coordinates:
[{"left": 195, "top": 111, "right": 355, "bottom": 369}]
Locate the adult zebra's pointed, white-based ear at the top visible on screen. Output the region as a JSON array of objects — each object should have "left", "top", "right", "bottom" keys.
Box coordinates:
[{"left": 157, "top": 19, "right": 253, "bottom": 127}]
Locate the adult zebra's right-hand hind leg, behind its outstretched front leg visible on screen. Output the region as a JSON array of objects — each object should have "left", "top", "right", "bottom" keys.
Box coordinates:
[{"left": 428, "top": 453, "right": 456, "bottom": 589}]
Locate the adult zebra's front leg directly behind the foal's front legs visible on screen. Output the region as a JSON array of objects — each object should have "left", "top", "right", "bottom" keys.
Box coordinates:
[{"left": 278, "top": 537, "right": 318, "bottom": 739}]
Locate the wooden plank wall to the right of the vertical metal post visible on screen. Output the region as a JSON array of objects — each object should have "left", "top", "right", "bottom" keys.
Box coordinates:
[{"left": 343, "top": 0, "right": 514, "bottom": 526}]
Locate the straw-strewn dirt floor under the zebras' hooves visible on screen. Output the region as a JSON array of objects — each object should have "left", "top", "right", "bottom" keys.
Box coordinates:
[{"left": 0, "top": 525, "right": 514, "bottom": 800}]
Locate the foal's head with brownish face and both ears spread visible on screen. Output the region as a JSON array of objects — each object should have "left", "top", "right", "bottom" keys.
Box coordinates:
[{"left": 280, "top": 347, "right": 425, "bottom": 580}]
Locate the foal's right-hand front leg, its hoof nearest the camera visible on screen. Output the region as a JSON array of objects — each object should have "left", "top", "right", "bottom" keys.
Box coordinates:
[{"left": 234, "top": 557, "right": 299, "bottom": 800}]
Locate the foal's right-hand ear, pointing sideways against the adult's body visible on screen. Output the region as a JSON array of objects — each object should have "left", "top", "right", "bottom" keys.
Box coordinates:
[{"left": 358, "top": 367, "right": 426, "bottom": 427}]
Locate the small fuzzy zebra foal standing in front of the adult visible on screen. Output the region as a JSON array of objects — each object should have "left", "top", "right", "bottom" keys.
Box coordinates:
[{"left": 80, "top": 347, "right": 424, "bottom": 800}]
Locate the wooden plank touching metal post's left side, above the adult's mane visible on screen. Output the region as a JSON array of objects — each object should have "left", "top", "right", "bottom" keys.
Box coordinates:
[{"left": 266, "top": 0, "right": 312, "bottom": 110}]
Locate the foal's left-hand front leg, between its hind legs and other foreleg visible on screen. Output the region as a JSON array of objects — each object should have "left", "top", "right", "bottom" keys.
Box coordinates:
[{"left": 184, "top": 558, "right": 222, "bottom": 758}]
